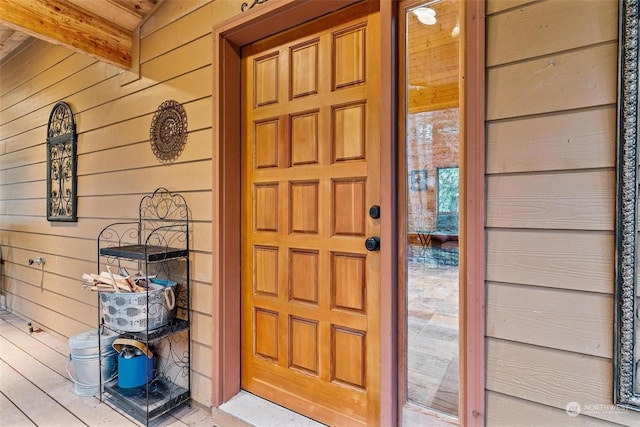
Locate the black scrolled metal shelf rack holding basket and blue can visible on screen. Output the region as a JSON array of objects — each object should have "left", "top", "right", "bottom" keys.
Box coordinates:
[{"left": 98, "top": 188, "right": 191, "bottom": 426}]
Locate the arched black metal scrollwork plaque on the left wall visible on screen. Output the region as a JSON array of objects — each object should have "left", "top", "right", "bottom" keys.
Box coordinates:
[{"left": 47, "top": 101, "right": 78, "bottom": 221}]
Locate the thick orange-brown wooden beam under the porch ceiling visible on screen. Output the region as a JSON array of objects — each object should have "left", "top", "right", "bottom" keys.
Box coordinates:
[{"left": 0, "top": 0, "right": 133, "bottom": 69}]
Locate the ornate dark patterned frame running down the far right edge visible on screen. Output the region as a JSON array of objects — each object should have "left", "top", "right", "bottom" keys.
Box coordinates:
[{"left": 614, "top": 0, "right": 640, "bottom": 410}]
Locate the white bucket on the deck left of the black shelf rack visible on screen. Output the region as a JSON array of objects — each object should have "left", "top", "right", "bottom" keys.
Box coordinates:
[{"left": 67, "top": 329, "right": 119, "bottom": 396}]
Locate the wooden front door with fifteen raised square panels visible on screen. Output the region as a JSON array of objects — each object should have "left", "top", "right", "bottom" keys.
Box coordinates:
[{"left": 241, "top": 2, "right": 384, "bottom": 425}]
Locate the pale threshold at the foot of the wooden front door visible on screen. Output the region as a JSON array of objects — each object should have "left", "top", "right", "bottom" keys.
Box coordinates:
[{"left": 218, "top": 390, "right": 325, "bottom": 427}]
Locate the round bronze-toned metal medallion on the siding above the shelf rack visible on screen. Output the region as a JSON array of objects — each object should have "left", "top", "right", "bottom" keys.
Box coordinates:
[{"left": 149, "top": 100, "right": 187, "bottom": 163}]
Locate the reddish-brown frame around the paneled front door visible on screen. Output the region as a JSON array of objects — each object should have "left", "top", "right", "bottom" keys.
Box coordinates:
[{"left": 211, "top": 0, "right": 397, "bottom": 425}]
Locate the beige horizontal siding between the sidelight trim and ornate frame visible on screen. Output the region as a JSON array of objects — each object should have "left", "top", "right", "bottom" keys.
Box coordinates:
[{"left": 486, "top": 0, "right": 640, "bottom": 427}]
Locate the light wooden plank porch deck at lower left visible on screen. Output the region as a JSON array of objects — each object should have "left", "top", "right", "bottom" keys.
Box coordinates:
[{"left": 0, "top": 310, "right": 249, "bottom": 427}]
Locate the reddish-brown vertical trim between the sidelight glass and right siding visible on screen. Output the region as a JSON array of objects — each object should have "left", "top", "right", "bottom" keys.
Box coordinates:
[{"left": 460, "top": 0, "right": 485, "bottom": 427}]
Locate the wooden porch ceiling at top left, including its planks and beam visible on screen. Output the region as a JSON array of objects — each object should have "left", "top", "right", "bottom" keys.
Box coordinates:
[{"left": 0, "top": 0, "right": 162, "bottom": 69}]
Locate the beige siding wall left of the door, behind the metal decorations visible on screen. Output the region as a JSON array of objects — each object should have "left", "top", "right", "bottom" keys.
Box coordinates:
[{"left": 0, "top": 0, "right": 241, "bottom": 406}]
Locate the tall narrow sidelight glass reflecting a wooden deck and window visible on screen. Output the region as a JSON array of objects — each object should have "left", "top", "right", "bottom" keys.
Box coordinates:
[{"left": 405, "top": 0, "right": 460, "bottom": 417}]
